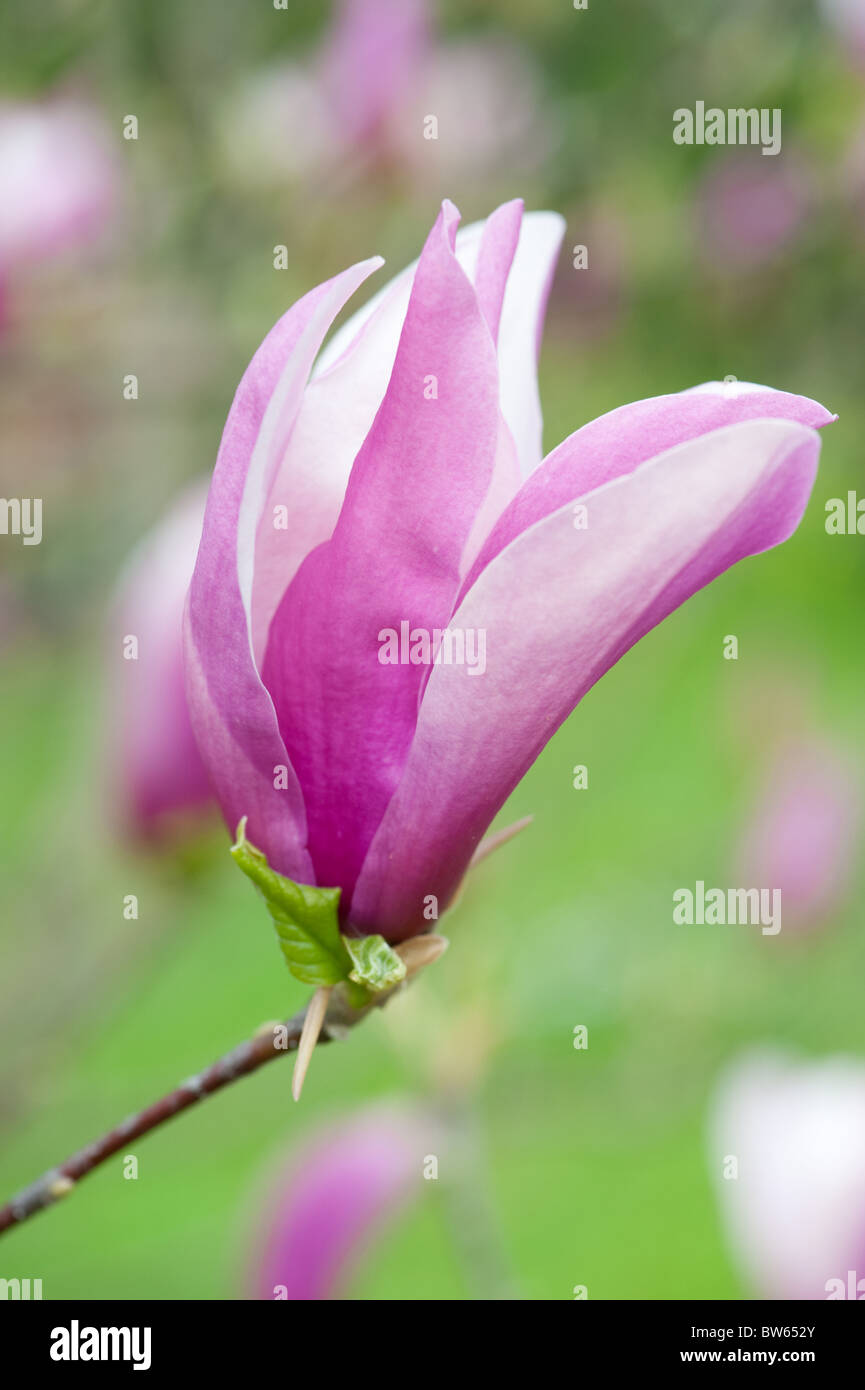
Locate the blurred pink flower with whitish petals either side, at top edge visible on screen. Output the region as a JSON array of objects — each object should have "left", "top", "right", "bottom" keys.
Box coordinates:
[{"left": 217, "top": 0, "right": 551, "bottom": 190}]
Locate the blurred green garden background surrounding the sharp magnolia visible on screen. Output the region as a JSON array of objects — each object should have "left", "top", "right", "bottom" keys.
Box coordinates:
[{"left": 0, "top": 0, "right": 865, "bottom": 1300}]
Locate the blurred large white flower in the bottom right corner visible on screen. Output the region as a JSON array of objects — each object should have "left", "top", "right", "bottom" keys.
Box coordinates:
[{"left": 711, "top": 1054, "right": 865, "bottom": 1300}]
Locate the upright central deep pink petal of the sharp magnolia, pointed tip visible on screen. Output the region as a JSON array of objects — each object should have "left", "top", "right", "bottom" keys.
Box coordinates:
[{"left": 264, "top": 204, "right": 498, "bottom": 904}]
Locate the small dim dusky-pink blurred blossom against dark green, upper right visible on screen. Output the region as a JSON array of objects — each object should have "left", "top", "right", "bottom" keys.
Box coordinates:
[{"left": 697, "top": 152, "right": 815, "bottom": 271}]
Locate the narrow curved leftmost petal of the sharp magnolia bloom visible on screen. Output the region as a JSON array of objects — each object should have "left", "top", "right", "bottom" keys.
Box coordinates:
[{"left": 185, "top": 260, "right": 381, "bottom": 883}]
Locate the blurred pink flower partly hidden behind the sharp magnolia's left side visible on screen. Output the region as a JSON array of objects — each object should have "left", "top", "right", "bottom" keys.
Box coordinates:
[{"left": 111, "top": 482, "right": 213, "bottom": 838}]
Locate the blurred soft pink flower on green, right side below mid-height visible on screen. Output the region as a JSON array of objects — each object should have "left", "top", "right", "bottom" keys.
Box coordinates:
[{"left": 736, "top": 735, "right": 861, "bottom": 931}]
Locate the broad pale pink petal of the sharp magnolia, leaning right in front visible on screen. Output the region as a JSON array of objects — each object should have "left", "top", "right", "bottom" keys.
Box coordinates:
[{"left": 352, "top": 420, "right": 819, "bottom": 940}]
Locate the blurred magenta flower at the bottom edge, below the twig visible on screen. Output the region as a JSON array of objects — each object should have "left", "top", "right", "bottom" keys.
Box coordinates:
[{"left": 249, "top": 1105, "right": 433, "bottom": 1300}]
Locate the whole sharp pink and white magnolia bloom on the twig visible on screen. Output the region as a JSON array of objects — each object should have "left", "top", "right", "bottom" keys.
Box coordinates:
[{"left": 186, "top": 202, "right": 832, "bottom": 942}]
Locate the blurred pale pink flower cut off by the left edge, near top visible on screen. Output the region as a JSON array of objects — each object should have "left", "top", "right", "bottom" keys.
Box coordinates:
[{"left": 0, "top": 99, "right": 117, "bottom": 318}]
